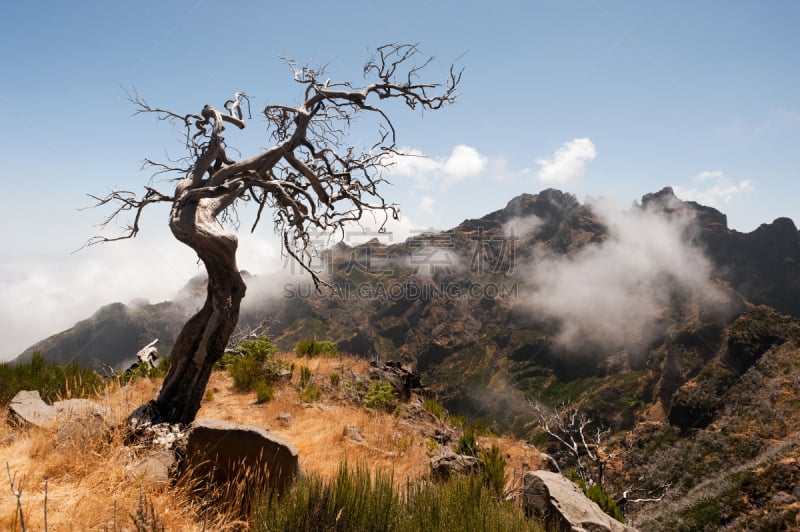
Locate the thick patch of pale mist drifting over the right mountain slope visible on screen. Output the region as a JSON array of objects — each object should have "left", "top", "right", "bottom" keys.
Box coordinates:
[{"left": 526, "top": 202, "right": 715, "bottom": 352}]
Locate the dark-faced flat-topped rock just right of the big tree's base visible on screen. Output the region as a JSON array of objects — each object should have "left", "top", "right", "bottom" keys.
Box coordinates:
[{"left": 182, "top": 419, "right": 303, "bottom": 498}]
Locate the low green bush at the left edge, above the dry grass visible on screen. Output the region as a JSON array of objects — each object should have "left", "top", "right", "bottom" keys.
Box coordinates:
[{"left": 0, "top": 351, "right": 106, "bottom": 404}]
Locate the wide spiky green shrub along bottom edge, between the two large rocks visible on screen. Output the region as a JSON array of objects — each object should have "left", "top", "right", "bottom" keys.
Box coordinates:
[{"left": 252, "top": 463, "right": 544, "bottom": 532}]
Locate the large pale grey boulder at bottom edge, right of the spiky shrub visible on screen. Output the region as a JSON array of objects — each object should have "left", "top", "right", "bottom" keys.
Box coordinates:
[{"left": 522, "top": 471, "right": 636, "bottom": 532}]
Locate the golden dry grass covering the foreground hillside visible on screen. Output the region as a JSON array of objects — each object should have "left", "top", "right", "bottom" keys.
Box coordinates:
[{"left": 0, "top": 355, "right": 538, "bottom": 531}]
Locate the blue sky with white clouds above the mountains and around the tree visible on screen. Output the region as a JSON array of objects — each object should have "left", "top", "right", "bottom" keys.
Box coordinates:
[{"left": 0, "top": 0, "right": 800, "bottom": 359}]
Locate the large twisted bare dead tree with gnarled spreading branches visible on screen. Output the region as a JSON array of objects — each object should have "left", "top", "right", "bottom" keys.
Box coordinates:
[{"left": 89, "top": 44, "right": 461, "bottom": 424}]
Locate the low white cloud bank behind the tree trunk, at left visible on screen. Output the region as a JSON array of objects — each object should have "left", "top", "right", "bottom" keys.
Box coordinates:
[{"left": 0, "top": 230, "right": 282, "bottom": 361}]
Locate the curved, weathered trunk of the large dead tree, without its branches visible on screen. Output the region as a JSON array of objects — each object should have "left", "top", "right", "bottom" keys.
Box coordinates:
[{"left": 152, "top": 193, "right": 246, "bottom": 425}]
